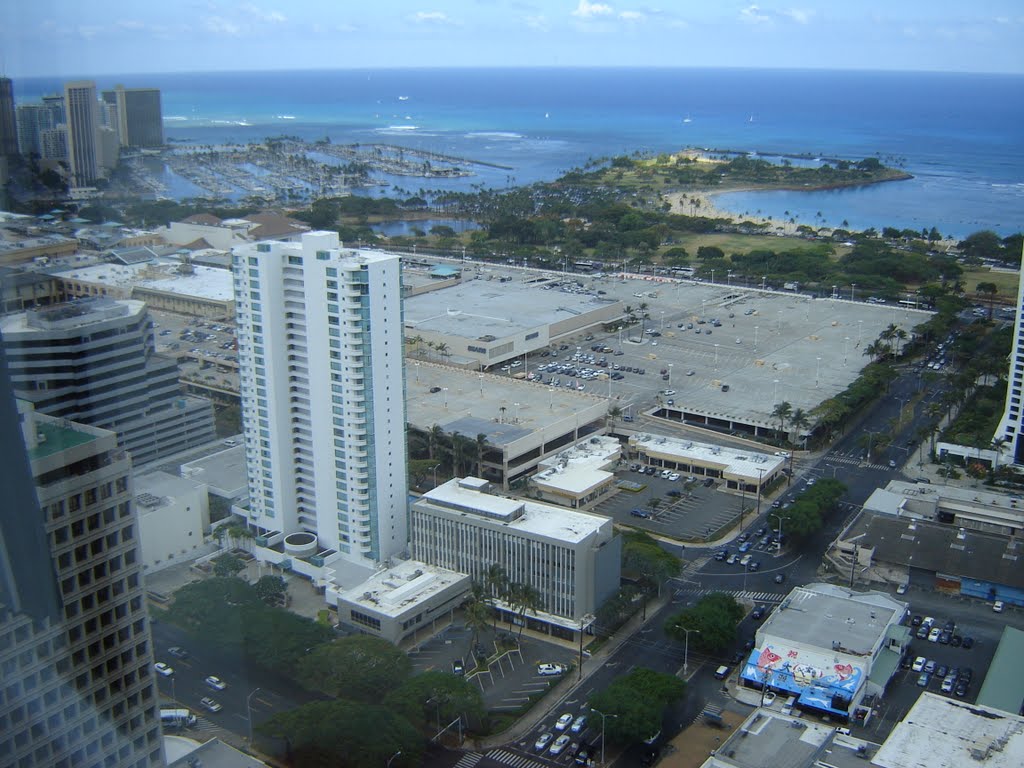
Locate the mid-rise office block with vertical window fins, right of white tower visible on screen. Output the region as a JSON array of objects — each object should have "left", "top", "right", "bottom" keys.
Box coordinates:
[{"left": 410, "top": 477, "right": 622, "bottom": 639}]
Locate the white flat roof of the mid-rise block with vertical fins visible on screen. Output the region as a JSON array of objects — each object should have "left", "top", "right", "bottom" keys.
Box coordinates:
[{"left": 415, "top": 477, "right": 611, "bottom": 544}]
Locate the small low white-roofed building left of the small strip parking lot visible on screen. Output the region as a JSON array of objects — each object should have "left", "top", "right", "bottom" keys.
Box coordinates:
[{"left": 529, "top": 435, "right": 622, "bottom": 509}]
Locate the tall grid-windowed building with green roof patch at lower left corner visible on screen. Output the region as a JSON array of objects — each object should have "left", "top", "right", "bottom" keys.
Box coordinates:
[{"left": 0, "top": 352, "right": 164, "bottom": 768}]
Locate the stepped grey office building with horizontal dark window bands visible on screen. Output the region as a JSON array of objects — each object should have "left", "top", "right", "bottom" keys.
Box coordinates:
[{"left": 0, "top": 298, "right": 215, "bottom": 466}]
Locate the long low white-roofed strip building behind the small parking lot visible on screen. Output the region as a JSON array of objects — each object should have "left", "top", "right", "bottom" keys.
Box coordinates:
[{"left": 629, "top": 432, "right": 787, "bottom": 495}]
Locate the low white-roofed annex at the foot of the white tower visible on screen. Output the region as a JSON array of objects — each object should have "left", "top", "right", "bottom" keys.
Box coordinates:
[{"left": 327, "top": 560, "right": 471, "bottom": 645}]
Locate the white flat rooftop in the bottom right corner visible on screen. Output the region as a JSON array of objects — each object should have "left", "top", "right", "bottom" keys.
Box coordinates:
[{"left": 871, "top": 691, "right": 1024, "bottom": 768}]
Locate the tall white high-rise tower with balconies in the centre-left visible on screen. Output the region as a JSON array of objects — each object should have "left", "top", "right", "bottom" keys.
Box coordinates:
[{"left": 233, "top": 231, "right": 409, "bottom": 565}]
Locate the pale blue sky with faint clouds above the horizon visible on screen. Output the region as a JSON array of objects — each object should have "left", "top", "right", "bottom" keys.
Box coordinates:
[{"left": 6, "top": 0, "right": 1024, "bottom": 78}]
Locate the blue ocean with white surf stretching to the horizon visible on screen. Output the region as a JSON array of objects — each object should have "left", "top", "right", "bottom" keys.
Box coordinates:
[{"left": 14, "top": 69, "right": 1024, "bottom": 238}]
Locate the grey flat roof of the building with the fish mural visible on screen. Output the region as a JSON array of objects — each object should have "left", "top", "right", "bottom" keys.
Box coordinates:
[{"left": 758, "top": 584, "right": 906, "bottom": 655}]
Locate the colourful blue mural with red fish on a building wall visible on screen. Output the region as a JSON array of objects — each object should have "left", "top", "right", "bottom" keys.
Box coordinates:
[{"left": 742, "top": 645, "right": 864, "bottom": 699}]
